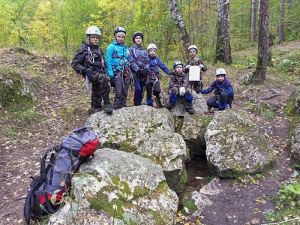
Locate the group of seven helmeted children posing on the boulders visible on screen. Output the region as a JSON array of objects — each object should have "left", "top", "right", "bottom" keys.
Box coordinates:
[{"left": 72, "top": 26, "right": 234, "bottom": 114}]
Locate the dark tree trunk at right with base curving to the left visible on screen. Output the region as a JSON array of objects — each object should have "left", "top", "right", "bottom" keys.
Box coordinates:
[{"left": 250, "top": 0, "right": 271, "bottom": 84}]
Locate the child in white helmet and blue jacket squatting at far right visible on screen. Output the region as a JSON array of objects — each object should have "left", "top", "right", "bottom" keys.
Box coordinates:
[{"left": 200, "top": 68, "right": 234, "bottom": 111}]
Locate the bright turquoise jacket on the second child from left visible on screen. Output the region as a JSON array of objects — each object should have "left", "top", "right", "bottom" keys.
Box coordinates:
[{"left": 106, "top": 40, "right": 129, "bottom": 77}]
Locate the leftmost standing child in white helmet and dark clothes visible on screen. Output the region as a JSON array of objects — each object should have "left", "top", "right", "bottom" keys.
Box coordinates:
[{"left": 71, "top": 26, "right": 113, "bottom": 114}]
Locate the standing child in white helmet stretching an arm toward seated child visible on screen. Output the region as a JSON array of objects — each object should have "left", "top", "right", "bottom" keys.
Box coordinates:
[{"left": 146, "top": 43, "right": 172, "bottom": 108}]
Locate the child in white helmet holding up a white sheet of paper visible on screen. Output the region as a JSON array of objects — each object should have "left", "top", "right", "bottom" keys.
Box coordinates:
[{"left": 184, "top": 45, "right": 207, "bottom": 92}]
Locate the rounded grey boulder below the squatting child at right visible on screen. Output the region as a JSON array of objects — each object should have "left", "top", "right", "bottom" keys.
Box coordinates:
[{"left": 205, "top": 110, "right": 276, "bottom": 177}]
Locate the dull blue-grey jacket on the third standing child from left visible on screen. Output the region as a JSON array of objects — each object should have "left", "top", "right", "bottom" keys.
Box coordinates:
[{"left": 129, "top": 44, "right": 150, "bottom": 73}]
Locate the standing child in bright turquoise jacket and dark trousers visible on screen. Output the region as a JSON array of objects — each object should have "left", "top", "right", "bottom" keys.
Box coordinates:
[{"left": 106, "top": 26, "right": 133, "bottom": 109}]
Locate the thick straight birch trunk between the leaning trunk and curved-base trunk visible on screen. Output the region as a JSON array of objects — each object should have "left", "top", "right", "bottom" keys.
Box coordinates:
[{"left": 215, "top": 0, "right": 232, "bottom": 64}]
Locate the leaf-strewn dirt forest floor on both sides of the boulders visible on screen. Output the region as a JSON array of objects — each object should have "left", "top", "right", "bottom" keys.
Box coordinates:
[{"left": 0, "top": 41, "right": 300, "bottom": 225}]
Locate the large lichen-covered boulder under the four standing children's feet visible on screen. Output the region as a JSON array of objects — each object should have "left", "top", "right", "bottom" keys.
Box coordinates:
[{"left": 87, "top": 106, "right": 189, "bottom": 192}]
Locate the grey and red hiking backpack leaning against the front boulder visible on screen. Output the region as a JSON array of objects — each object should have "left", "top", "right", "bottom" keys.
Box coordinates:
[{"left": 24, "top": 127, "right": 100, "bottom": 224}]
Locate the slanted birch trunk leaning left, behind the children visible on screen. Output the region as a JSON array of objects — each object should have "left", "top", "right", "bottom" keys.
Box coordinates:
[{"left": 168, "top": 0, "right": 190, "bottom": 55}]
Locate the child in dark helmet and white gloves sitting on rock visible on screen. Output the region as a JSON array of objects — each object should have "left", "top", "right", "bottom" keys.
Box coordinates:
[{"left": 167, "top": 61, "right": 195, "bottom": 114}]
